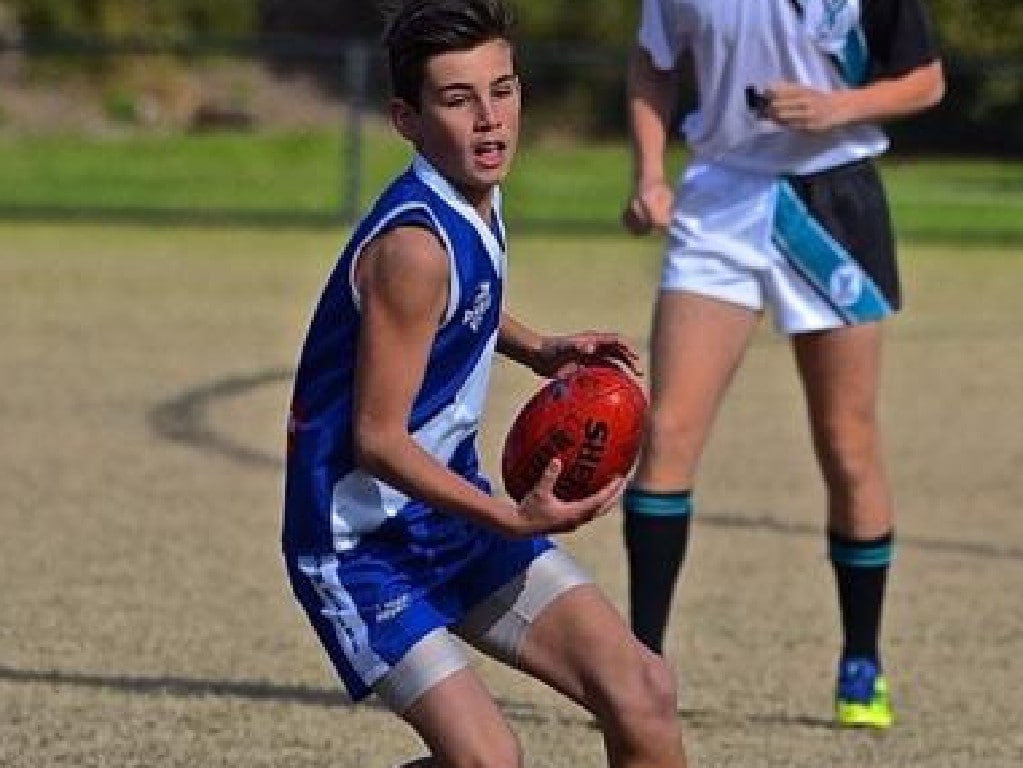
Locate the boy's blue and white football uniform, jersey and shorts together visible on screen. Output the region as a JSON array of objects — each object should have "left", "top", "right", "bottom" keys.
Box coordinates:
[{"left": 282, "top": 155, "right": 552, "bottom": 699}]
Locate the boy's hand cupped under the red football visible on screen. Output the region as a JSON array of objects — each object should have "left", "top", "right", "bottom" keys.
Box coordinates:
[{"left": 518, "top": 458, "right": 625, "bottom": 536}]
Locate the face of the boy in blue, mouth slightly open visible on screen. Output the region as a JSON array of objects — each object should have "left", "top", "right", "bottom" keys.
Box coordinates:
[{"left": 392, "top": 40, "right": 522, "bottom": 213}]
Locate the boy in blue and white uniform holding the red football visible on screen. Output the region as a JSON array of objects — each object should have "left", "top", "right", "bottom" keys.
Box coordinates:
[{"left": 282, "top": 0, "right": 684, "bottom": 768}]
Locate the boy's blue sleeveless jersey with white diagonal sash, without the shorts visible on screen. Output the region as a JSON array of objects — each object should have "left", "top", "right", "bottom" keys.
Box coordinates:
[{"left": 282, "top": 155, "right": 505, "bottom": 554}]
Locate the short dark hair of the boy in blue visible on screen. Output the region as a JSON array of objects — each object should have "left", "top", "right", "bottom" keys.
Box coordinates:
[{"left": 384, "top": 0, "right": 513, "bottom": 109}]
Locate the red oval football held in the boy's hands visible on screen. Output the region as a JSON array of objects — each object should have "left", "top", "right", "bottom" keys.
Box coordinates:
[{"left": 501, "top": 364, "right": 647, "bottom": 501}]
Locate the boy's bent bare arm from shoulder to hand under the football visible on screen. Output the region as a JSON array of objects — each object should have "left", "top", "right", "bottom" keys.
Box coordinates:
[{"left": 354, "top": 228, "right": 621, "bottom": 536}]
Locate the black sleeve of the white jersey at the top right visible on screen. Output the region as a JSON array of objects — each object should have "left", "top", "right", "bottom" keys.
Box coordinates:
[{"left": 862, "top": 0, "right": 938, "bottom": 80}]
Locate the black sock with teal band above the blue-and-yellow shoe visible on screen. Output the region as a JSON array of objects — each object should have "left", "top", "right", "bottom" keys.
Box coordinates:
[{"left": 828, "top": 531, "right": 894, "bottom": 663}]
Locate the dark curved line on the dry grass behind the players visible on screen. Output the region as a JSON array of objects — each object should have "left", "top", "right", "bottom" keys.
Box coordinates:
[{"left": 148, "top": 368, "right": 1023, "bottom": 560}]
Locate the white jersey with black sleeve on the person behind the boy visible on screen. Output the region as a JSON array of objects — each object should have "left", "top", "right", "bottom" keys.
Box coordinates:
[{"left": 638, "top": 0, "right": 937, "bottom": 174}]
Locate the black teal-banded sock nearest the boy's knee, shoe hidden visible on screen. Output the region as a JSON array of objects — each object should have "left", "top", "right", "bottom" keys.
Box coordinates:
[{"left": 623, "top": 488, "right": 692, "bottom": 653}]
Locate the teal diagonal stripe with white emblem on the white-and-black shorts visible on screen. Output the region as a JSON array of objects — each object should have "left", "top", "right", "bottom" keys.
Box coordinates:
[{"left": 771, "top": 181, "right": 892, "bottom": 325}]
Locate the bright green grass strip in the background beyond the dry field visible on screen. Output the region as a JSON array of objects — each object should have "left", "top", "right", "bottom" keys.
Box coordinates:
[{"left": 0, "top": 127, "right": 1023, "bottom": 244}]
